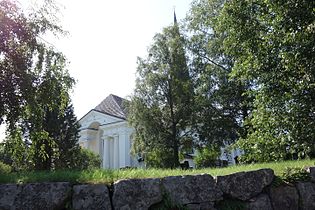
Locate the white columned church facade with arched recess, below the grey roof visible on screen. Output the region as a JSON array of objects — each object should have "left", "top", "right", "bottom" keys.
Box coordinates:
[{"left": 79, "top": 111, "right": 135, "bottom": 168}]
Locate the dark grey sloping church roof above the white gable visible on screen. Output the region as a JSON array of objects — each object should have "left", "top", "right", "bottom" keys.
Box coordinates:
[{"left": 93, "top": 94, "right": 127, "bottom": 119}]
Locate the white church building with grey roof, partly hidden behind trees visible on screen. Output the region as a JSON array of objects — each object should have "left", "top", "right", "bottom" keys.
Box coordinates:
[{"left": 79, "top": 94, "right": 241, "bottom": 169}]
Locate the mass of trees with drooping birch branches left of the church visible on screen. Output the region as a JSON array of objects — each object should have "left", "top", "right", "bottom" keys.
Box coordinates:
[{"left": 0, "top": 0, "right": 79, "bottom": 170}]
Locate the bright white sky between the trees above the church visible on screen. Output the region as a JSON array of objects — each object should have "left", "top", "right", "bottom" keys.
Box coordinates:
[{"left": 0, "top": 0, "right": 192, "bottom": 140}]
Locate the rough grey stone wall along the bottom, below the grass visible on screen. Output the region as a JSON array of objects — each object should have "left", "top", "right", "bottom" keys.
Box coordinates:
[{"left": 0, "top": 167, "right": 315, "bottom": 210}]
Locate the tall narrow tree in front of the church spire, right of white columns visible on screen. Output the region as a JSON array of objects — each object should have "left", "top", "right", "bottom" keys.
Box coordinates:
[{"left": 128, "top": 16, "right": 193, "bottom": 167}]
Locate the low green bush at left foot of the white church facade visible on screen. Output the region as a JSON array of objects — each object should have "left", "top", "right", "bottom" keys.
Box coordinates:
[{"left": 73, "top": 148, "right": 102, "bottom": 170}]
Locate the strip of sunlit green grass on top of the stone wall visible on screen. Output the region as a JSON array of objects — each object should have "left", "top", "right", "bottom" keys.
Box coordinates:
[{"left": 0, "top": 160, "right": 315, "bottom": 184}]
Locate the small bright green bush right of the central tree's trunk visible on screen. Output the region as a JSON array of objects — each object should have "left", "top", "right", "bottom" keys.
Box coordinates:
[{"left": 194, "top": 147, "right": 220, "bottom": 168}]
